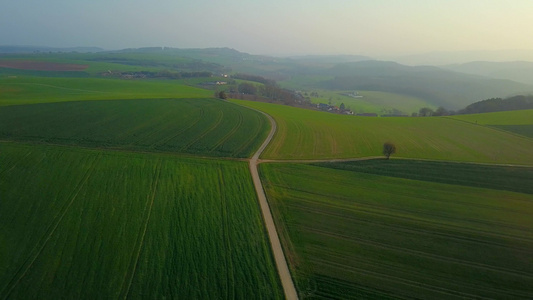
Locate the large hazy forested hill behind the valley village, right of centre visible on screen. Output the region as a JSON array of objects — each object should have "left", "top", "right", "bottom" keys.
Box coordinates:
[{"left": 318, "top": 61, "right": 533, "bottom": 109}]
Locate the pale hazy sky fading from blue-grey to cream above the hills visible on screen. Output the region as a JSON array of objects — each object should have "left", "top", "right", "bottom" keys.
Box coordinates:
[{"left": 0, "top": 0, "right": 533, "bottom": 56}]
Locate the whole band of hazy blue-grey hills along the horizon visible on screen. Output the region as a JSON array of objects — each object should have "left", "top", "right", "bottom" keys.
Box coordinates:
[{"left": 0, "top": 46, "right": 533, "bottom": 110}]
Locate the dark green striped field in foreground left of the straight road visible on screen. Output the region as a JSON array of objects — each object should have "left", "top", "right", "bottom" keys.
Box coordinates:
[{"left": 0, "top": 143, "right": 283, "bottom": 299}]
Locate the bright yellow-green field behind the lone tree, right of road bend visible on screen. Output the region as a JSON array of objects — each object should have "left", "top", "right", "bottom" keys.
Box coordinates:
[{"left": 232, "top": 100, "right": 533, "bottom": 165}]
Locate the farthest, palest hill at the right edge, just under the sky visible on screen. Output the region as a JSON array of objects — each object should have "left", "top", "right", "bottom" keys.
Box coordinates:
[{"left": 443, "top": 61, "right": 533, "bottom": 85}]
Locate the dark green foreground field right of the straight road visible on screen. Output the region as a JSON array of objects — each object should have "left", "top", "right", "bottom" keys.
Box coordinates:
[{"left": 260, "top": 160, "right": 533, "bottom": 299}]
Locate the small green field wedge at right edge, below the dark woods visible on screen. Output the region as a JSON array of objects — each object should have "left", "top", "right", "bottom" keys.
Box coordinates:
[{"left": 451, "top": 109, "right": 533, "bottom": 138}]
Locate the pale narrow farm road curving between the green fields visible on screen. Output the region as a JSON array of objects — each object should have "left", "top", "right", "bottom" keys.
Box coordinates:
[{"left": 250, "top": 109, "right": 298, "bottom": 300}]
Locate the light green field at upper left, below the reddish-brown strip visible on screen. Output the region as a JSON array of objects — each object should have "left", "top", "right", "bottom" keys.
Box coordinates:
[{"left": 0, "top": 77, "right": 213, "bottom": 106}]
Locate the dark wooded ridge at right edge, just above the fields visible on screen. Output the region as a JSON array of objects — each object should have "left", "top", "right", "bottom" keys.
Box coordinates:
[{"left": 458, "top": 95, "right": 533, "bottom": 114}]
